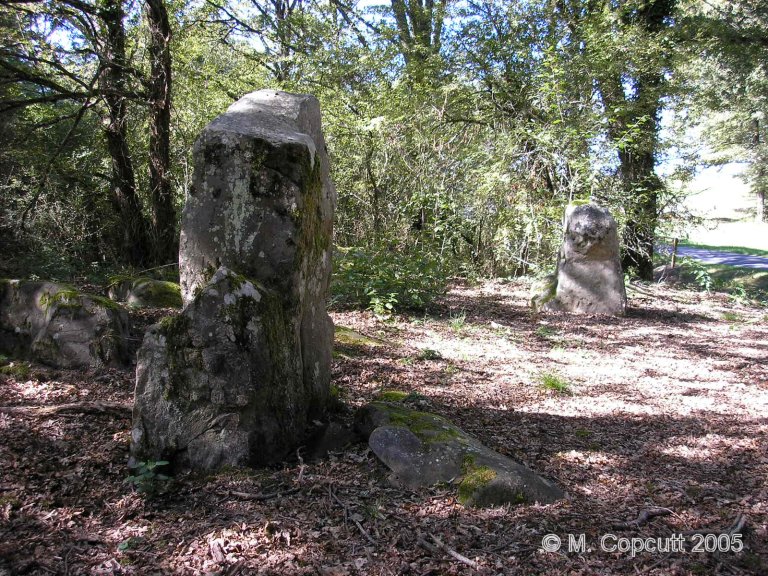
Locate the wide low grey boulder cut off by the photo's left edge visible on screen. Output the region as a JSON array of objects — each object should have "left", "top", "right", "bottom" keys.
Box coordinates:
[{"left": 0, "top": 280, "right": 129, "bottom": 368}]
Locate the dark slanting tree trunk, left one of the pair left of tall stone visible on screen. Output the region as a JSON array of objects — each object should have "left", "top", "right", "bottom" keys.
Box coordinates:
[{"left": 99, "top": 0, "right": 149, "bottom": 266}]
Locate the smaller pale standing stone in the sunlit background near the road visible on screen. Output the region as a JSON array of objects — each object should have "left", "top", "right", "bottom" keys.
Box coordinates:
[{"left": 544, "top": 204, "right": 627, "bottom": 316}]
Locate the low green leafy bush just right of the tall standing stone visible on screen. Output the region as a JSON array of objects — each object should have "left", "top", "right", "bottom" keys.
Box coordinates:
[{"left": 331, "top": 248, "right": 448, "bottom": 316}]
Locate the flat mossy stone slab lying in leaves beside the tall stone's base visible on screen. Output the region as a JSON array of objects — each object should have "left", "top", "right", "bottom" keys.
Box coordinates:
[{"left": 355, "top": 401, "right": 565, "bottom": 507}]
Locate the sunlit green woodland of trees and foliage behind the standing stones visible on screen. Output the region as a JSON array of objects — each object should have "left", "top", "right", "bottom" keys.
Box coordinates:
[{"left": 0, "top": 0, "right": 768, "bottom": 286}]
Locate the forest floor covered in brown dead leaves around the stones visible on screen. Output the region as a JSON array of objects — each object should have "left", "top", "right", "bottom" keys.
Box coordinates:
[{"left": 0, "top": 282, "right": 768, "bottom": 576}]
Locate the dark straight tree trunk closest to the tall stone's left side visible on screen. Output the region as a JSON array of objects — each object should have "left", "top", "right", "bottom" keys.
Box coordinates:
[{"left": 145, "top": 0, "right": 178, "bottom": 264}]
